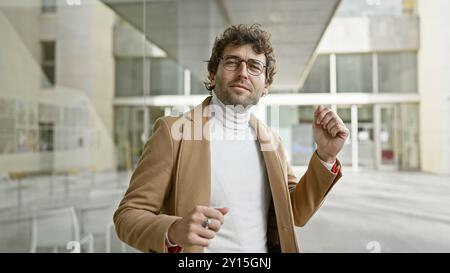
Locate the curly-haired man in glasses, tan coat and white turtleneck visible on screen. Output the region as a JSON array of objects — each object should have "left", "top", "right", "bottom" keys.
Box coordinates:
[{"left": 114, "top": 25, "right": 349, "bottom": 252}]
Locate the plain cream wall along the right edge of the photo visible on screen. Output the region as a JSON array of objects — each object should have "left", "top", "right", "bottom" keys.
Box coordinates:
[{"left": 418, "top": 0, "right": 450, "bottom": 174}]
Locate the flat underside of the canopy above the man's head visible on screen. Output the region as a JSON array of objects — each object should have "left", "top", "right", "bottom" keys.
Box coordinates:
[{"left": 103, "top": 0, "right": 340, "bottom": 90}]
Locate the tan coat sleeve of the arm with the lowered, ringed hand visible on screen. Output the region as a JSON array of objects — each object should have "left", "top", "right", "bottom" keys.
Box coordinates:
[{"left": 113, "top": 118, "right": 179, "bottom": 252}]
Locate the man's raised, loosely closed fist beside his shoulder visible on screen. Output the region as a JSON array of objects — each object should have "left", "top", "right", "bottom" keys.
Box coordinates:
[{"left": 312, "top": 105, "right": 350, "bottom": 163}]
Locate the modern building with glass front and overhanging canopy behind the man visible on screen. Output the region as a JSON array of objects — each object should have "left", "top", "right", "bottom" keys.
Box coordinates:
[{"left": 0, "top": 0, "right": 450, "bottom": 174}]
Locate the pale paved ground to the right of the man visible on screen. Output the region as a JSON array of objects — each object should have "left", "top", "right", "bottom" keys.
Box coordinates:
[{"left": 298, "top": 169, "right": 450, "bottom": 252}]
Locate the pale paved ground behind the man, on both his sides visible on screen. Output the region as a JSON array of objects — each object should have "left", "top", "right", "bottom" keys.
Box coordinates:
[{"left": 0, "top": 168, "right": 450, "bottom": 252}]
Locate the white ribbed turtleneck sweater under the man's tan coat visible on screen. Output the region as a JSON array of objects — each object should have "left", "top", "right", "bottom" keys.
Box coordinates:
[{"left": 205, "top": 92, "right": 270, "bottom": 252}]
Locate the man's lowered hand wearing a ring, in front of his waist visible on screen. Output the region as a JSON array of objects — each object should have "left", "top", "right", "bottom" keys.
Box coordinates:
[{"left": 168, "top": 206, "right": 229, "bottom": 247}]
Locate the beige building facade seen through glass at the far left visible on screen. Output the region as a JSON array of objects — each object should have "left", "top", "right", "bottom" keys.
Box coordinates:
[{"left": 0, "top": 0, "right": 115, "bottom": 174}]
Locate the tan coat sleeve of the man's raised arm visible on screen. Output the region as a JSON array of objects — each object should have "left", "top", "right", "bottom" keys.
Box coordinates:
[{"left": 281, "top": 144, "right": 342, "bottom": 226}]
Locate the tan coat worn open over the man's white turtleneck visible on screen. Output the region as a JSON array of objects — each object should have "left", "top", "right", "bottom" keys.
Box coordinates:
[{"left": 114, "top": 97, "right": 341, "bottom": 252}]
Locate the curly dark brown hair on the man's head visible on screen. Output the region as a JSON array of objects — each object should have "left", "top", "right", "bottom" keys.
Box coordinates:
[{"left": 203, "top": 24, "right": 276, "bottom": 91}]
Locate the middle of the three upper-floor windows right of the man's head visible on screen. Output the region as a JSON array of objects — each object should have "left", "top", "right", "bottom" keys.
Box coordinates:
[{"left": 336, "top": 54, "right": 373, "bottom": 93}]
